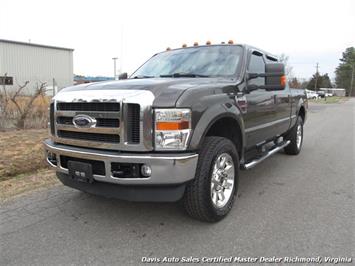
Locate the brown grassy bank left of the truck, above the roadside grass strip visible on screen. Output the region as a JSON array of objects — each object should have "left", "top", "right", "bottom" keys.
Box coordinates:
[{"left": 0, "top": 129, "right": 48, "bottom": 181}]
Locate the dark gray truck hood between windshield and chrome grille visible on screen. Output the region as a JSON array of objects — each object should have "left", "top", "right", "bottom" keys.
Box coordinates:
[{"left": 58, "top": 78, "right": 225, "bottom": 107}]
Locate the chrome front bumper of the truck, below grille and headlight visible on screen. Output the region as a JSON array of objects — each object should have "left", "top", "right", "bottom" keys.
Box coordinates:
[{"left": 43, "top": 139, "right": 198, "bottom": 185}]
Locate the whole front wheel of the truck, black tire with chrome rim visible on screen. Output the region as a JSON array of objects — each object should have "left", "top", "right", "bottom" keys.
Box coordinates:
[{"left": 183, "top": 137, "right": 239, "bottom": 222}]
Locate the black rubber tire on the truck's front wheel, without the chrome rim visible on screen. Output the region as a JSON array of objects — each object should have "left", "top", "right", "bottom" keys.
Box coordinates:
[{"left": 183, "top": 137, "right": 239, "bottom": 222}]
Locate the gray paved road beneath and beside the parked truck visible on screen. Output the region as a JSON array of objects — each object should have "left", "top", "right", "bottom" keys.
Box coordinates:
[{"left": 0, "top": 100, "right": 355, "bottom": 265}]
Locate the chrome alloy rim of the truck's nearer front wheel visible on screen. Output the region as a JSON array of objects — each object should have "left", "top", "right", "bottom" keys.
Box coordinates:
[{"left": 211, "top": 153, "right": 235, "bottom": 208}]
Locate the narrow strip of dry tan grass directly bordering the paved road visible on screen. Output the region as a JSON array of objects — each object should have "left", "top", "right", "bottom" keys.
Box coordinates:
[{"left": 0, "top": 170, "right": 59, "bottom": 202}]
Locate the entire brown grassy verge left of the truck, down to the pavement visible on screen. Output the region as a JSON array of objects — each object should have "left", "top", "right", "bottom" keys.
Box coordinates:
[{"left": 0, "top": 129, "right": 59, "bottom": 202}]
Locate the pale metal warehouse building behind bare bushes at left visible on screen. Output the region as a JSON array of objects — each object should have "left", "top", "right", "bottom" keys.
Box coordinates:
[{"left": 0, "top": 39, "right": 74, "bottom": 94}]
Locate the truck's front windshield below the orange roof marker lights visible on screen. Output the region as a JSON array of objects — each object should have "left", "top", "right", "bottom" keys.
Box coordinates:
[{"left": 131, "top": 45, "right": 242, "bottom": 78}]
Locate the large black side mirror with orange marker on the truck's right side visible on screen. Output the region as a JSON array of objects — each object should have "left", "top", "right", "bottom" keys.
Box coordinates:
[{"left": 247, "top": 63, "right": 287, "bottom": 91}]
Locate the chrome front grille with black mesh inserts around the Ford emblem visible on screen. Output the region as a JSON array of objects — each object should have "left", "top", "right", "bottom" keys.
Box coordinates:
[{"left": 51, "top": 90, "right": 154, "bottom": 151}]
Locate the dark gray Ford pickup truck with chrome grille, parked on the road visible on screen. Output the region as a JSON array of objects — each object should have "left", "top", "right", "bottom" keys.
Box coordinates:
[{"left": 44, "top": 44, "right": 307, "bottom": 222}]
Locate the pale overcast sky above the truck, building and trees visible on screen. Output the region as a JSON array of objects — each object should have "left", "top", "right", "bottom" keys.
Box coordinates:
[{"left": 0, "top": 0, "right": 355, "bottom": 78}]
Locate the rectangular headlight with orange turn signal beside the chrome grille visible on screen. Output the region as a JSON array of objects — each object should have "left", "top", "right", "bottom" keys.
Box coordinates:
[{"left": 155, "top": 109, "right": 191, "bottom": 150}]
